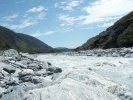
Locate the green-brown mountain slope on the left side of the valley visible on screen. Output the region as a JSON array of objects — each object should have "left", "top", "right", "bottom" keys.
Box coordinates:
[{"left": 0, "top": 26, "right": 53, "bottom": 53}]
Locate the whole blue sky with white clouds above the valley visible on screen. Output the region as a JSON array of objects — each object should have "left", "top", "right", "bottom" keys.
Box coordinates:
[{"left": 0, "top": 0, "right": 133, "bottom": 48}]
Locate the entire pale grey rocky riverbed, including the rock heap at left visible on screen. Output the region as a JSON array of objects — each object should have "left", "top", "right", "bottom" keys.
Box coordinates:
[{"left": 0, "top": 48, "right": 133, "bottom": 100}]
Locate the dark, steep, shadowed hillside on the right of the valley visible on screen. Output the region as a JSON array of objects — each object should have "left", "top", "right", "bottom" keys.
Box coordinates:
[{"left": 76, "top": 12, "right": 133, "bottom": 50}]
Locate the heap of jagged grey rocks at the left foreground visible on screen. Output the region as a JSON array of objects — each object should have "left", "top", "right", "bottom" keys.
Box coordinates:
[{"left": 0, "top": 49, "right": 62, "bottom": 100}]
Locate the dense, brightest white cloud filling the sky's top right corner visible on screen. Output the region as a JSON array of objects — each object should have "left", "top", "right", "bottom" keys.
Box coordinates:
[{"left": 82, "top": 0, "right": 133, "bottom": 24}]
